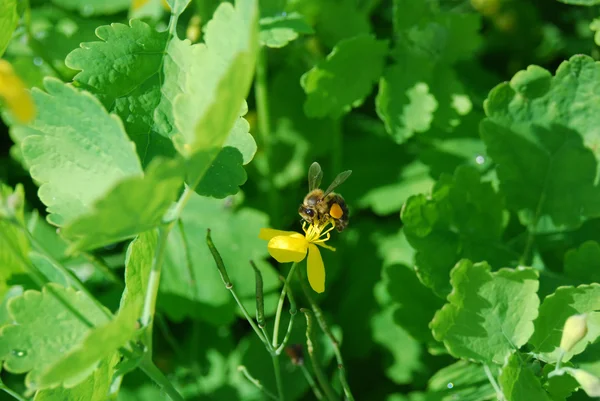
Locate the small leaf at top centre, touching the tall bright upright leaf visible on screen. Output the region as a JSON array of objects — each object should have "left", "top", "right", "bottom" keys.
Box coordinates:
[{"left": 259, "top": 12, "right": 314, "bottom": 48}]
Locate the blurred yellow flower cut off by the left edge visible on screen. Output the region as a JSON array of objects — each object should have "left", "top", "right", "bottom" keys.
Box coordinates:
[{"left": 0, "top": 59, "right": 35, "bottom": 123}]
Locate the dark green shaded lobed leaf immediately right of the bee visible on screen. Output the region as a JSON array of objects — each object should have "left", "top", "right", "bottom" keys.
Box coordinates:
[{"left": 401, "top": 166, "right": 516, "bottom": 297}]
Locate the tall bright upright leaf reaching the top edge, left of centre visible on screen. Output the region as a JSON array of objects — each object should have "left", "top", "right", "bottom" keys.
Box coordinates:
[{"left": 174, "top": 0, "right": 258, "bottom": 155}]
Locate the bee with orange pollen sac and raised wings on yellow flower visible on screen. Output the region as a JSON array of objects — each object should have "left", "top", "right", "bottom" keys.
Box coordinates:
[{"left": 298, "top": 162, "right": 352, "bottom": 232}]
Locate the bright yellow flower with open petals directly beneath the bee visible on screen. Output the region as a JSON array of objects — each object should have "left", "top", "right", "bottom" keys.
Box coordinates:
[{"left": 258, "top": 221, "right": 335, "bottom": 293}]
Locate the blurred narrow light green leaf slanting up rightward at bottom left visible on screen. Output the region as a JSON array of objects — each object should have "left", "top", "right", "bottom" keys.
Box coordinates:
[{"left": 28, "top": 306, "right": 137, "bottom": 389}]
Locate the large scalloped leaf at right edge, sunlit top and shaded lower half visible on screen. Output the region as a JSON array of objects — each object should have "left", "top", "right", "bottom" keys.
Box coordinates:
[{"left": 481, "top": 55, "right": 600, "bottom": 228}]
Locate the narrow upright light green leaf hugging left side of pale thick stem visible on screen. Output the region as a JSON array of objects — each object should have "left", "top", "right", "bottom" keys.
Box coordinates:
[{"left": 120, "top": 230, "right": 158, "bottom": 317}]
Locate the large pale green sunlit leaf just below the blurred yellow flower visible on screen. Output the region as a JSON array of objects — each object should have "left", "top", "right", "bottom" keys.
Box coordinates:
[{"left": 17, "top": 78, "right": 142, "bottom": 226}]
